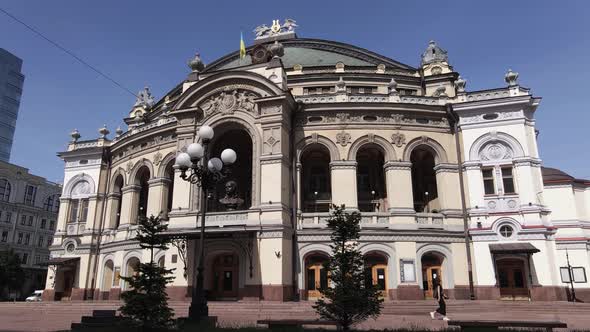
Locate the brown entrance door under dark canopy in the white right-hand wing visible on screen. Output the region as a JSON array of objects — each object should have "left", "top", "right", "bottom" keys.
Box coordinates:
[{"left": 496, "top": 259, "right": 529, "bottom": 300}]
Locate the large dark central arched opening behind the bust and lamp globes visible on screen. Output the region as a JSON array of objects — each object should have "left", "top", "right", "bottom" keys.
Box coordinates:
[{"left": 207, "top": 125, "right": 253, "bottom": 212}]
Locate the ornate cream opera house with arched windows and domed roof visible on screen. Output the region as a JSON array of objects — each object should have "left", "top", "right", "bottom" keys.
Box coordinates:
[{"left": 44, "top": 20, "right": 590, "bottom": 301}]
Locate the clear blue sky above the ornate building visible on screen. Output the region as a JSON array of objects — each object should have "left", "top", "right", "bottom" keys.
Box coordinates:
[{"left": 0, "top": 0, "right": 590, "bottom": 182}]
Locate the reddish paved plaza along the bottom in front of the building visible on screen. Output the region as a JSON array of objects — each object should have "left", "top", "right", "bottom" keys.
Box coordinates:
[{"left": 0, "top": 301, "right": 590, "bottom": 331}]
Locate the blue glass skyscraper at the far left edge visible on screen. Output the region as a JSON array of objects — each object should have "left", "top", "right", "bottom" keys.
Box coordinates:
[{"left": 0, "top": 48, "right": 25, "bottom": 162}]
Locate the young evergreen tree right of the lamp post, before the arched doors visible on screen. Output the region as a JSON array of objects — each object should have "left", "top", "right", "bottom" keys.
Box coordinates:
[{"left": 313, "top": 205, "right": 383, "bottom": 331}]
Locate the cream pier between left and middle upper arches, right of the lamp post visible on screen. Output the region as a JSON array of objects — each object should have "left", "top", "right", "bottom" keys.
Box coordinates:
[{"left": 330, "top": 160, "right": 358, "bottom": 209}]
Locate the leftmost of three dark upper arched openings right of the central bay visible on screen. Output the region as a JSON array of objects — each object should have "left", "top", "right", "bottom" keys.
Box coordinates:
[{"left": 299, "top": 144, "right": 332, "bottom": 212}]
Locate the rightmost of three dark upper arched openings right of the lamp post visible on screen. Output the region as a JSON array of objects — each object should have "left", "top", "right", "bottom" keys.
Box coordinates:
[{"left": 410, "top": 146, "right": 440, "bottom": 213}]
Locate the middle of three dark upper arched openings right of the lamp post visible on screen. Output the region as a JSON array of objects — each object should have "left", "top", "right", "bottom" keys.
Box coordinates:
[{"left": 356, "top": 144, "right": 388, "bottom": 212}]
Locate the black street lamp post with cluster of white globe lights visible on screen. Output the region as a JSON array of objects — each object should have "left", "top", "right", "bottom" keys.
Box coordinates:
[{"left": 174, "top": 126, "right": 237, "bottom": 321}]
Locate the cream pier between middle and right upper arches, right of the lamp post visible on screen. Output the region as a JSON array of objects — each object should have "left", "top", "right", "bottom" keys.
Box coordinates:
[{"left": 383, "top": 161, "right": 416, "bottom": 216}]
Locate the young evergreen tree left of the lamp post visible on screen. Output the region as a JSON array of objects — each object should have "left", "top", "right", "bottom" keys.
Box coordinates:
[{"left": 119, "top": 216, "right": 174, "bottom": 330}]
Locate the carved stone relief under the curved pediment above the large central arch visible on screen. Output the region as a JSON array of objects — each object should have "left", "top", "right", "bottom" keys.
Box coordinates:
[{"left": 199, "top": 89, "right": 258, "bottom": 117}]
